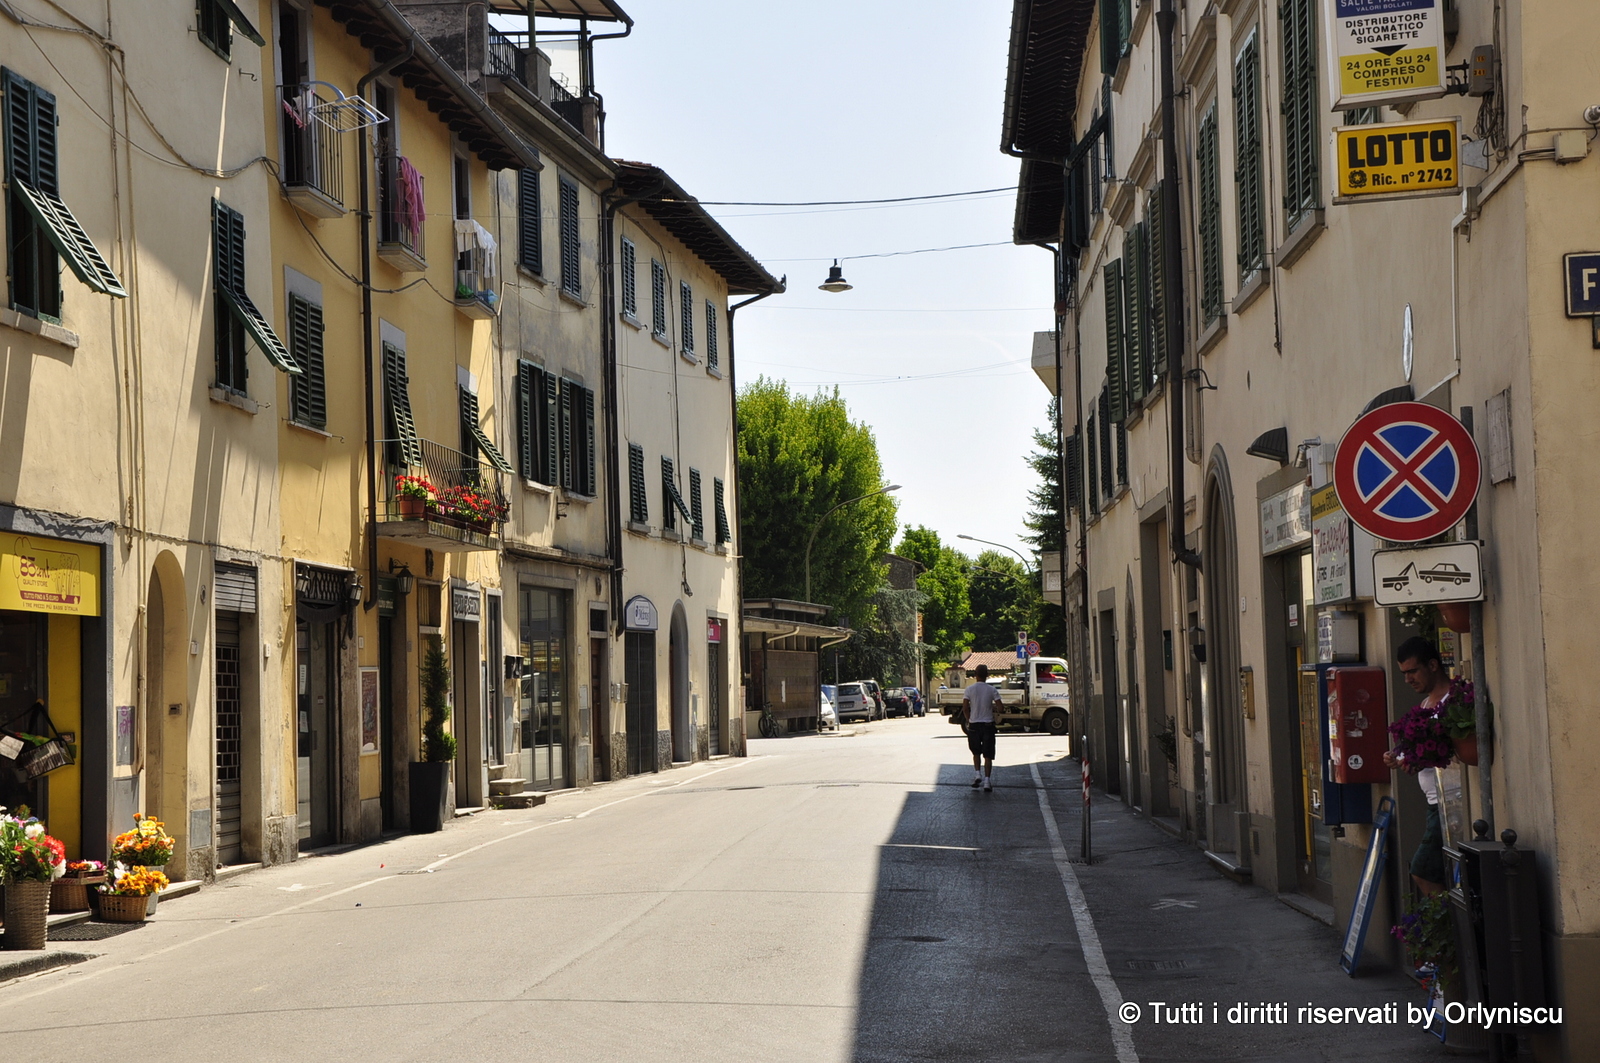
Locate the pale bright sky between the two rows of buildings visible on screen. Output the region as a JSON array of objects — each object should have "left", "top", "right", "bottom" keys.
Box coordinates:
[{"left": 582, "top": 0, "right": 1053, "bottom": 556}]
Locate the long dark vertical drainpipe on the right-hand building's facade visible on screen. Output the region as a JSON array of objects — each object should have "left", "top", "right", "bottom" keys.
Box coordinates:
[{"left": 1155, "top": 0, "right": 1200, "bottom": 568}]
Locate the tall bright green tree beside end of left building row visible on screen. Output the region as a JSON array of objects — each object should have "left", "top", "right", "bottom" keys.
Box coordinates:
[{"left": 738, "top": 376, "right": 898, "bottom": 624}]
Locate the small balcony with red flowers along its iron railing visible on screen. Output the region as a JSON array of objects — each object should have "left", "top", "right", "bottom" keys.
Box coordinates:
[{"left": 378, "top": 439, "right": 509, "bottom": 552}]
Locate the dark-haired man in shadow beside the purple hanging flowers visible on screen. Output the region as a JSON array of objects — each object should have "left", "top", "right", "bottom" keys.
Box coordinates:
[{"left": 1384, "top": 636, "right": 1451, "bottom": 897}]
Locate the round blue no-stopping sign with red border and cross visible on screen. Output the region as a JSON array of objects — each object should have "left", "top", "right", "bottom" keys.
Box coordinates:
[{"left": 1333, "top": 402, "right": 1480, "bottom": 543}]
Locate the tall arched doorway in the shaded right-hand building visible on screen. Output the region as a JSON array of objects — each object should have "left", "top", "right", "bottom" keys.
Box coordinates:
[{"left": 1202, "top": 450, "right": 1248, "bottom": 863}]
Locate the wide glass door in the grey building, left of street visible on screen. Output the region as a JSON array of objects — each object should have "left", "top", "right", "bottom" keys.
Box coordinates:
[{"left": 518, "top": 584, "right": 571, "bottom": 789}]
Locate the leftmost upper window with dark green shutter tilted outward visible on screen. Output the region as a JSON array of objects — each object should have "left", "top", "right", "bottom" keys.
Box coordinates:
[{"left": 0, "top": 70, "right": 128, "bottom": 313}]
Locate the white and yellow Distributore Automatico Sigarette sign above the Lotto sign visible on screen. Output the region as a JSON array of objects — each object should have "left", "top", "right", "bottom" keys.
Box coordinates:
[{"left": 1323, "top": 0, "right": 1446, "bottom": 110}]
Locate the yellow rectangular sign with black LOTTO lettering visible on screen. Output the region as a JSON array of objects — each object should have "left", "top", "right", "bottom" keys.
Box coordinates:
[{"left": 1333, "top": 118, "right": 1461, "bottom": 199}]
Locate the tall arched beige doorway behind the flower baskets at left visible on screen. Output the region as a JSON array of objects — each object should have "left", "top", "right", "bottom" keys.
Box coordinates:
[{"left": 145, "top": 551, "right": 195, "bottom": 879}]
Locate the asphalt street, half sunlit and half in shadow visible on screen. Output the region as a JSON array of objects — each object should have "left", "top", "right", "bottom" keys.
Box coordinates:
[{"left": 0, "top": 717, "right": 1440, "bottom": 1063}]
